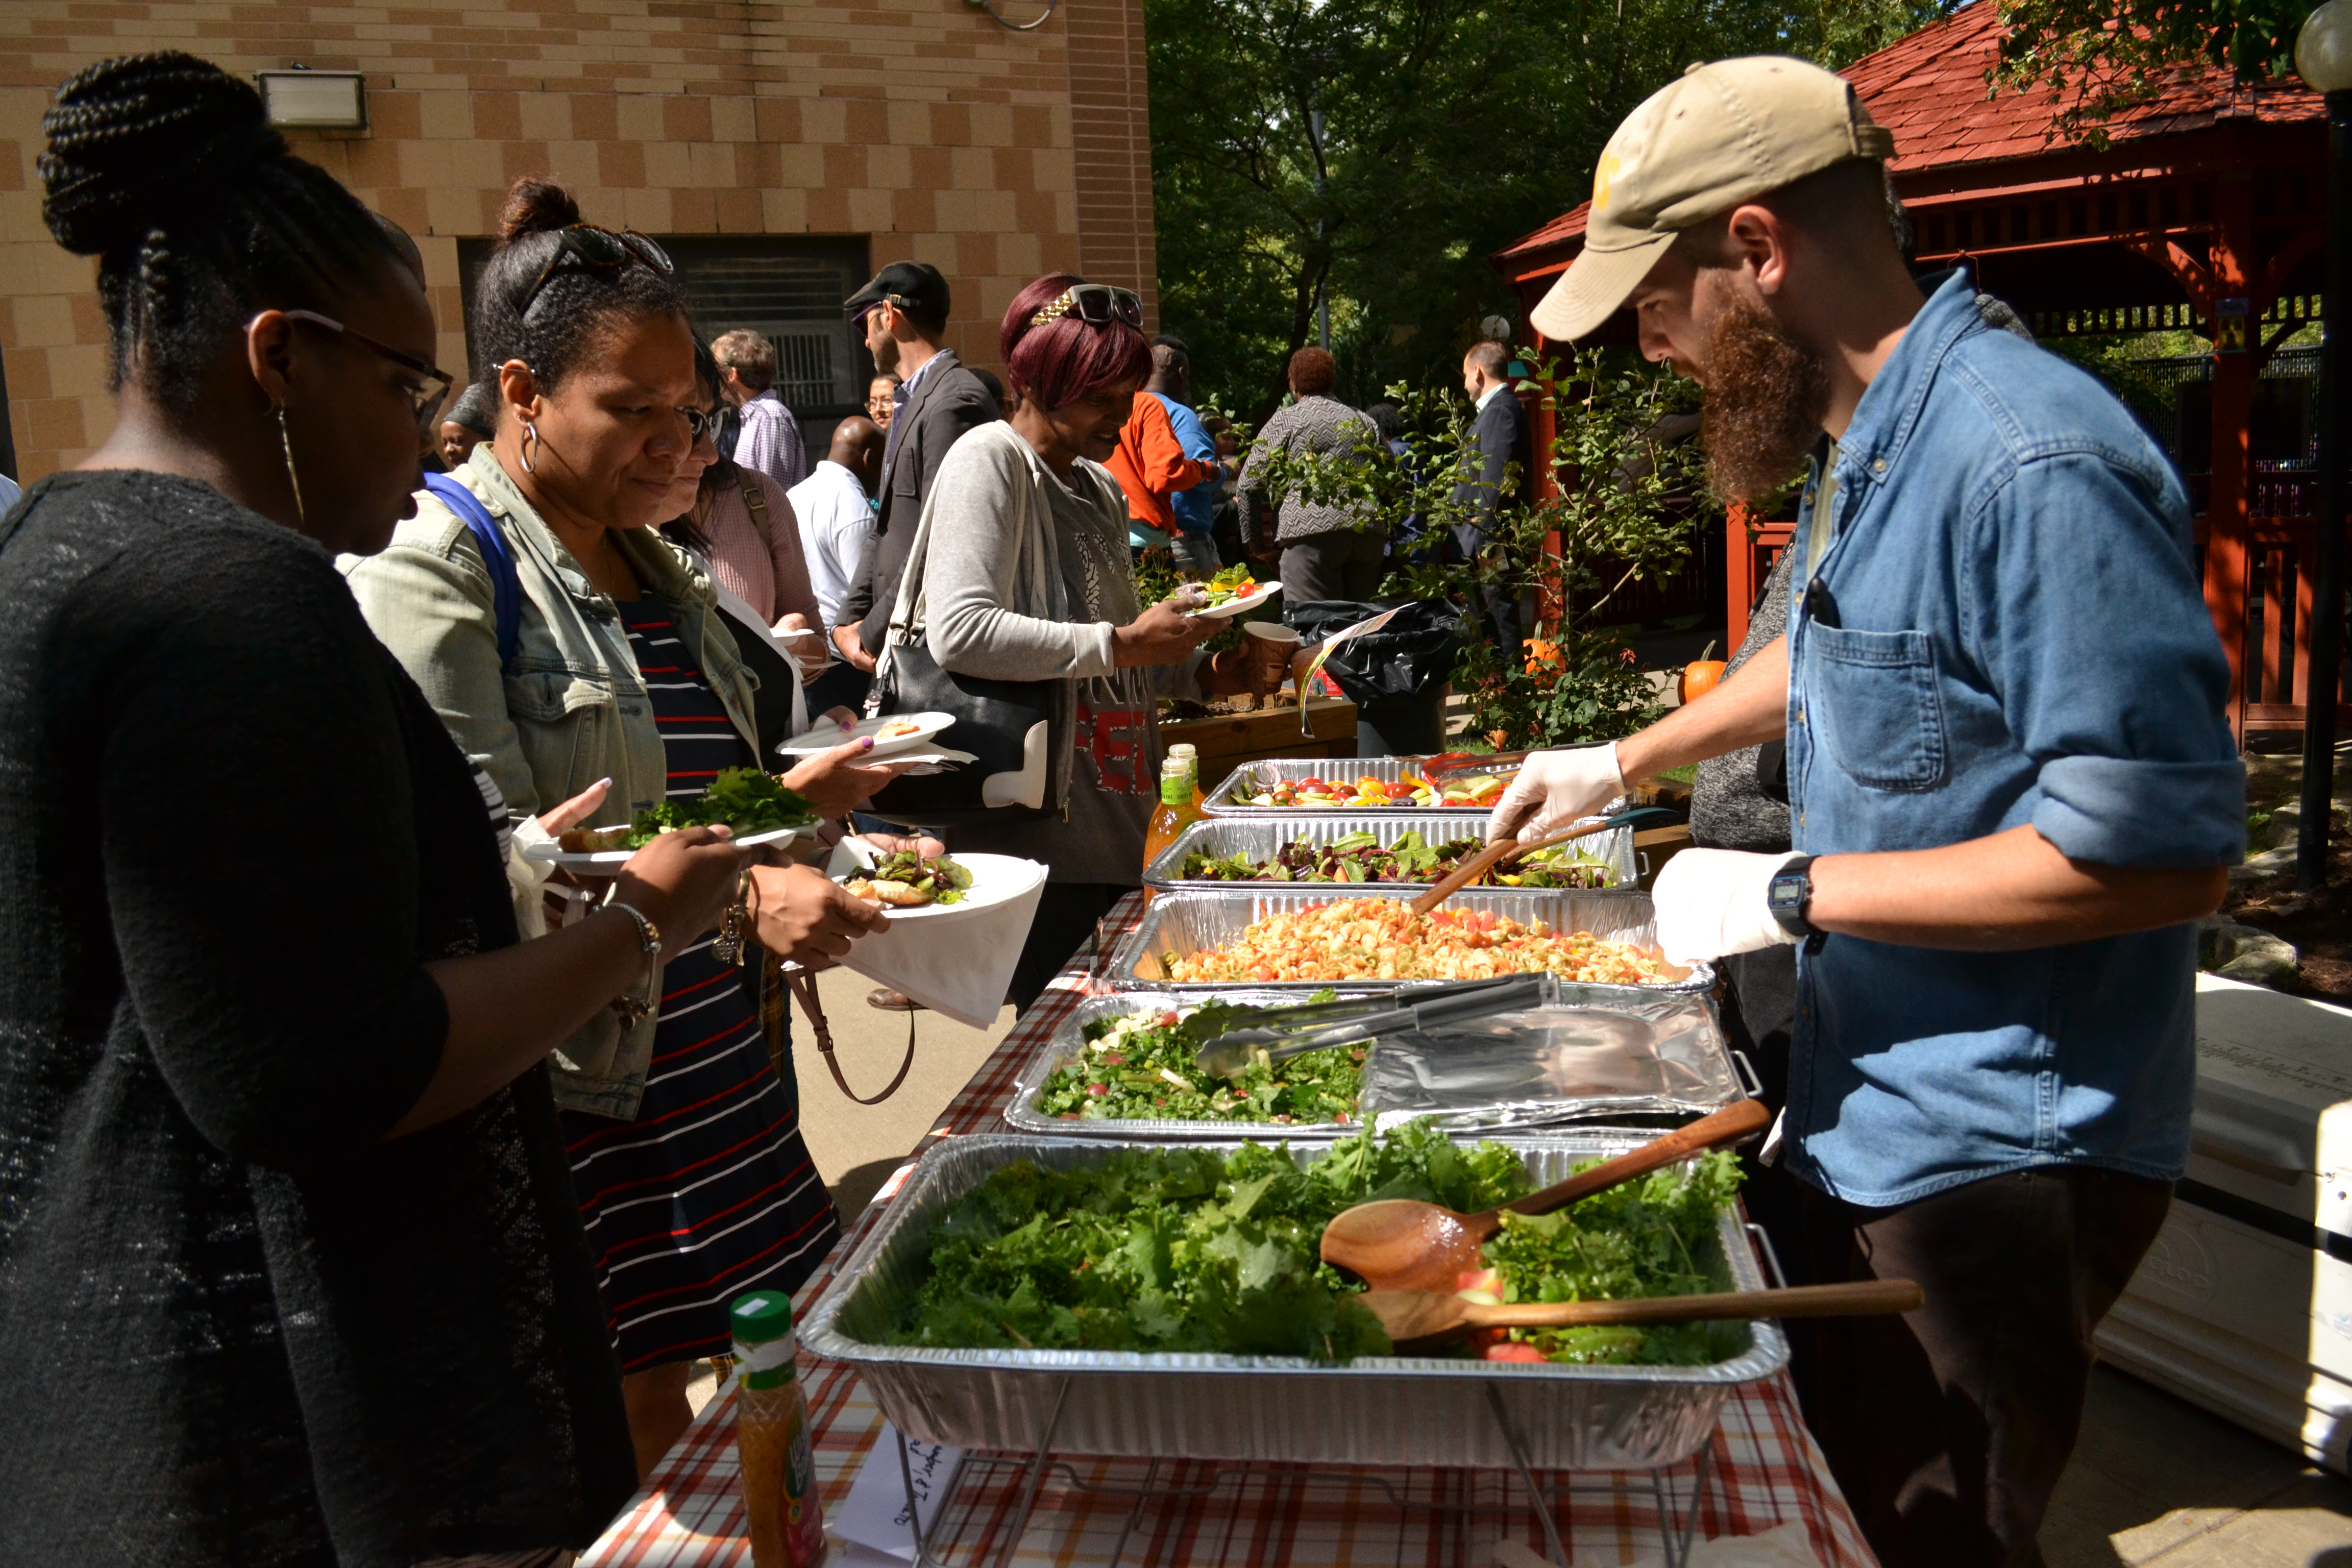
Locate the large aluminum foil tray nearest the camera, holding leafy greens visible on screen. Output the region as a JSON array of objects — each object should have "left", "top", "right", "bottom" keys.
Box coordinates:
[{"left": 800, "top": 1131, "right": 1787, "bottom": 1469}]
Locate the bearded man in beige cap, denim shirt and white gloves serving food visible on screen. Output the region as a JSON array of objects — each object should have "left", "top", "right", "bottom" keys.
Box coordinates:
[{"left": 1489, "top": 57, "right": 2244, "bottom": 1568}]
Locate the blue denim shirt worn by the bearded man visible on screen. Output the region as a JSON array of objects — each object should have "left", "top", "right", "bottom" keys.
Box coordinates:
[{"left": 1785, "top": 275, "right": 2246, "bottom": 1206}]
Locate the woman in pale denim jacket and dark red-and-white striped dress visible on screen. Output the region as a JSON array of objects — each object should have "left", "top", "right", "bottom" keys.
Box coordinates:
[{"left": 351, "top": 179, "right": 894, "bottom": 1467}]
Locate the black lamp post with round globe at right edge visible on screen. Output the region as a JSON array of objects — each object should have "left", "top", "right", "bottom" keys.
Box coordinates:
[{"left": 2295, "top": 0, "right": 2352, "bottom": 891}]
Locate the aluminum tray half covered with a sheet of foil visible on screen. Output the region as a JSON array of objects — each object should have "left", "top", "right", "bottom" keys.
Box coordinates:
[{"left": 1004, "top": 981, "right": 1743, "bottom": 1142}]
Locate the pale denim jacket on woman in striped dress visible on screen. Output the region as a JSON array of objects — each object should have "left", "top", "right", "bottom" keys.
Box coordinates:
[{"left": 339, "top": 442, "right": 757, "bottom": 1121}]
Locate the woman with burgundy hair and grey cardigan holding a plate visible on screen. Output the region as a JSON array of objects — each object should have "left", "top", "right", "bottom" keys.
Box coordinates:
[{"left": 894, "top": 273, "right": 1282, "bottom": 1011}]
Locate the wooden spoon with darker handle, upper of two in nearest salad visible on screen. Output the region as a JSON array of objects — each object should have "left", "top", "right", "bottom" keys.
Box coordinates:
[{"left": 1322, "top": 1100, "right": 1771, "bottom": 1293}]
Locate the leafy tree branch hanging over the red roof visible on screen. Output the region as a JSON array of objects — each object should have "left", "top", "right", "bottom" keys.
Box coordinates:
[{"left": 1992, "top": 0, "right": 2314, "bottom": 146}]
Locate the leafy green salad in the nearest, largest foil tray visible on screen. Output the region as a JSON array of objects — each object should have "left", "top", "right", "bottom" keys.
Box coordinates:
[{"left": 887, "top": 1121, "right": 1745, "bottom": 1366}]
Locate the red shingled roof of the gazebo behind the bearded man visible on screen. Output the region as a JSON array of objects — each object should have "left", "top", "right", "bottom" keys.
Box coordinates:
[{"left": 1496, "top": 0, "right": 2326, "bottom": 263}]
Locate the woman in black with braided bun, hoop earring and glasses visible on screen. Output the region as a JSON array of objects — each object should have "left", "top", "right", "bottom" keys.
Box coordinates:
[{"left": 0, "top": 54, "right": 743, "bottom": 1568}]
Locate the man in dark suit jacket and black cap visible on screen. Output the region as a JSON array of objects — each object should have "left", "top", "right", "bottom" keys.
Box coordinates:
[{"left": 832, "top": 261, "right": 997, "bottom": 675}]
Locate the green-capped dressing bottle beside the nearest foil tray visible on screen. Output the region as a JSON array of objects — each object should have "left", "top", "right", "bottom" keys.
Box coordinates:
[{"left": 731, "top": 1291, "right": 825, "bottom": 1568}]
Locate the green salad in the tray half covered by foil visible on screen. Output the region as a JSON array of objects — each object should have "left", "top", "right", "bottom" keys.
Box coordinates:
[{"left": 1030, "top": 990, "right": 1369, "bottom": 1121}]
